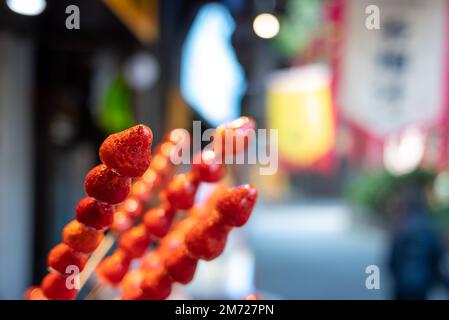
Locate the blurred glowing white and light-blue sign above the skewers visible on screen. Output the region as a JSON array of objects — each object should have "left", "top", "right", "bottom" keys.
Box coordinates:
[{"left": 181, "top": 3, "right": 246, "bottom": 126}]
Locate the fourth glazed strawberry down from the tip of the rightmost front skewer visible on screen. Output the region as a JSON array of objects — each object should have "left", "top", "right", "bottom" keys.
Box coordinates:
[{"left": 141, "top": 268, "right": 173, "bottom": 300}]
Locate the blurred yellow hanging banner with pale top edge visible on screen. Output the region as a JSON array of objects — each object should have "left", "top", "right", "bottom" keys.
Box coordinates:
[{"left": 267, "top": 65, "right": 335, "bottom": 172}]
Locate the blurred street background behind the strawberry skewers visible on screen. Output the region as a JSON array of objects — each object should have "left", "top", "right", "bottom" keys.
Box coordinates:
[{"left": 0, "top": 0, "right": 449, "bottom": 300}]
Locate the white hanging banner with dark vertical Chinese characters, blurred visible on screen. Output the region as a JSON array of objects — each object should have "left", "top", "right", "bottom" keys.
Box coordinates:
[{"left": 336, "top": 0, "right": 449, "bottom": 139}]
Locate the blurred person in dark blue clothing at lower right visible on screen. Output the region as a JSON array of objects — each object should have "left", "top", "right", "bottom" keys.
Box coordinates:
[{"left": 388, "top": 185, "right": 449, "bottom": 300}]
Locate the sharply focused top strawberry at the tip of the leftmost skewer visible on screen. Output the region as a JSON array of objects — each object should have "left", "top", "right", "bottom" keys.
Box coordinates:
[{"left": 100, "top": 125, "right": 153, "bottom": 178}]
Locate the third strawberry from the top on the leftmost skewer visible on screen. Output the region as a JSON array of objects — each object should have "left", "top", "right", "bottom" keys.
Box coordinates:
[{"left": 76, "top": 197, "right": 114, "bottom": 230}]
